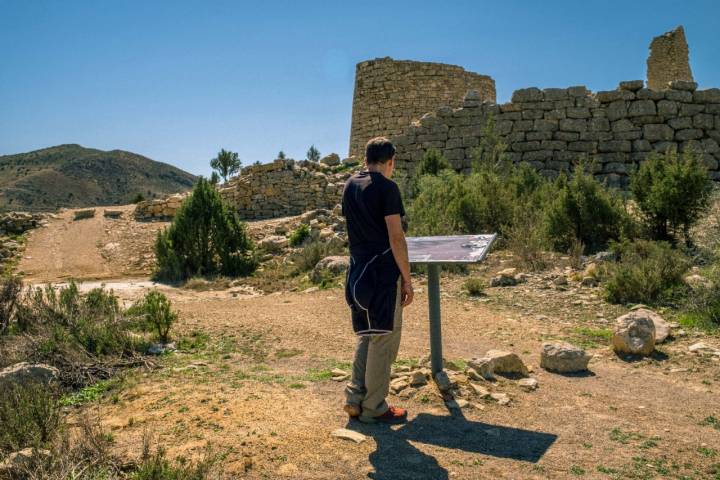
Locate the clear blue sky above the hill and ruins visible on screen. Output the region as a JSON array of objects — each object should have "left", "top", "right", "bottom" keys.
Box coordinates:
[{"left": 0, "top": 0, "right": 720, "bottom": 174}]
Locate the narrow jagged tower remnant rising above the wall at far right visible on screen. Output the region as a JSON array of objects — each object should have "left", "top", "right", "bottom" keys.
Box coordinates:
[{"left": 647, "top": 25, "right": 693, "bottom": 90}]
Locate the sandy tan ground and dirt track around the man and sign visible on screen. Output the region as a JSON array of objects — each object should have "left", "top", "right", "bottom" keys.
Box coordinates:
[{"left": 20, "top": 207, "right": 720, "bottom": 480}]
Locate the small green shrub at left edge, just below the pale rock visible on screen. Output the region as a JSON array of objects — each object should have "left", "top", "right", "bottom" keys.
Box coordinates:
[{"left": 0, "top": 382, "right": 62, "bottom": 454}]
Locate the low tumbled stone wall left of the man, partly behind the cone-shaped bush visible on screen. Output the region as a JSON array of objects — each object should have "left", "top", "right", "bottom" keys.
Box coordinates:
[{"left": 135, "top": 160, "right": 350, "bottom": 220}]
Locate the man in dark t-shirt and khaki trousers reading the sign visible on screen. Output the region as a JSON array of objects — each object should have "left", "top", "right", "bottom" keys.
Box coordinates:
[{"left": 342, "top": 137, "right": 413, "bottom": 423}]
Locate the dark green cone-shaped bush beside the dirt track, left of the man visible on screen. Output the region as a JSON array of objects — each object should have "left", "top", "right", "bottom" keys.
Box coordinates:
[{"left": 155, "top": 178, "right": 257, "bottom": 281}]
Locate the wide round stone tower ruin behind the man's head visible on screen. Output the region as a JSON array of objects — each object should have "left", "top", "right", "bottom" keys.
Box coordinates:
[{"left": 350, "top": 57, "right": 495, "bottom": 158}]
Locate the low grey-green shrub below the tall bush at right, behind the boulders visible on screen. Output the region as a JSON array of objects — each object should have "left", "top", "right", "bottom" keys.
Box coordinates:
[{"left": 602, "top": 240, "right": 690, "bottom": 304}]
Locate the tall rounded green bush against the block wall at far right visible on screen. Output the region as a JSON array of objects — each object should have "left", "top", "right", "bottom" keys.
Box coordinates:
[{"left": 630, "top": 149, "right": 713, "bottom": 241}]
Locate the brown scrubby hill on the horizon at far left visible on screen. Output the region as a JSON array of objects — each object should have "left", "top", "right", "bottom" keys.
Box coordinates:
[{"left": 0, "top": 145, "right": 195, "bottom": 211}]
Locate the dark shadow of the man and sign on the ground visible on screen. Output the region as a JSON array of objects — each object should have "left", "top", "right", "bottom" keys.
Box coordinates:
[{"left": 347, "top": 409, "right": 557, "bottom": 480}]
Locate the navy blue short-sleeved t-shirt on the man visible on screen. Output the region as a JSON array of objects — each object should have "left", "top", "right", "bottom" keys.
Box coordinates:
[{"left": 342, "top": 171, "right": 405, "bottom": 255}]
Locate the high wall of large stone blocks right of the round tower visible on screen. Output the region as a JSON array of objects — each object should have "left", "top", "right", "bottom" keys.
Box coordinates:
[{"left": 393, "top": 80, "right": 720, "bottom": 187}]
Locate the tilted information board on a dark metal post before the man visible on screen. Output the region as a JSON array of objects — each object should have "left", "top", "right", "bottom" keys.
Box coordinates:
[{"left": 407, "top": 234, "right": 497, "bottom": 378}]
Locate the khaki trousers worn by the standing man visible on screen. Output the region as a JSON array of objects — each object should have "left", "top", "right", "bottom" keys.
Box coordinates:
[{"left": 345, "top": 280, "right": 403, "bottom": 417}]
